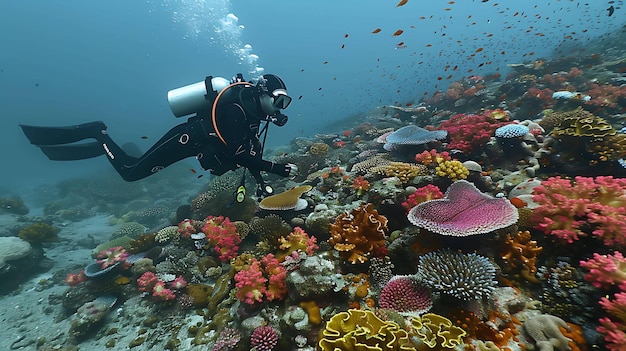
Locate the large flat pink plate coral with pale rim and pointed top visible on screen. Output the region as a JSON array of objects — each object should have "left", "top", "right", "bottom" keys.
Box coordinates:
[{"left": 407, "top": 180, "right": 518, "bottom": 236}]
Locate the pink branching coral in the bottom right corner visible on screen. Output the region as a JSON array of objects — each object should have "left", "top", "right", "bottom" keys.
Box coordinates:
[{"left": 597, "top": 292, "right": 626, "bottom": 351}]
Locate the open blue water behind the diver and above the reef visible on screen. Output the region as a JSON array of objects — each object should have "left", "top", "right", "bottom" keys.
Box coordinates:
[{"left": 0, "top": 0, "right": 624, "bottom": 190}]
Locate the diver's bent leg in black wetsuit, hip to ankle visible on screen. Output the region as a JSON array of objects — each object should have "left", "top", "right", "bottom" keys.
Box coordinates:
[{"left": 98, "top": 123, "right": 200, "bottom": 182}]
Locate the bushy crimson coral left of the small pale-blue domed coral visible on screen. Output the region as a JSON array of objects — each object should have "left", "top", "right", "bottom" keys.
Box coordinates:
[{"left": 437, "top": 114, "right": 507, "bottom": 154}]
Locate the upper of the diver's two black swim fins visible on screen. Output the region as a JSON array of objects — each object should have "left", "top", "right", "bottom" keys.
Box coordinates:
[{"left": 20, "top": 121, "right": 106, "bottom": 149}]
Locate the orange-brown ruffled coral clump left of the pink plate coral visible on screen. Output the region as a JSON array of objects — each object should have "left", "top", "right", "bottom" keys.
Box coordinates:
[{"left": 329, "top": 203, "right": 389, "bottom": 264}]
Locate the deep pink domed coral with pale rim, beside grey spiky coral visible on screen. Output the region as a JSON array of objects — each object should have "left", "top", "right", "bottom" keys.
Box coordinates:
[{"left": 378, "top": 275, "right": 433, "bottom": 315}]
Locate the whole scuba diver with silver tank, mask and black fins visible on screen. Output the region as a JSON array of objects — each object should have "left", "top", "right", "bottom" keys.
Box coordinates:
[{"left": 20, "top": 73, "right": 298, "bottom": 202}]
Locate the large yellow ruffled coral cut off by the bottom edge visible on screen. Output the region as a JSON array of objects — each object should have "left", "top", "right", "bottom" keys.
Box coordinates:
[{"left": 318, "top": 309, "right": 415, "bottom": 351}]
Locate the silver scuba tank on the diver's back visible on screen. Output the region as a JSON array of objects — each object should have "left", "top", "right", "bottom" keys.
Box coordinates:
[{"left": 167, "top": 75, "right": 232, "bottom": 117}]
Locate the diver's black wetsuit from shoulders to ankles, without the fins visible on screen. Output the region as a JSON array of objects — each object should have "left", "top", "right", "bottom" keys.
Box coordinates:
[{"left": 96, "top": 99, "right": 289, "bottom": 184}]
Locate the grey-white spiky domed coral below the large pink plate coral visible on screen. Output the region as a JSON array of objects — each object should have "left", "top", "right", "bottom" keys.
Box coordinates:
[{"left": 417, "top": 249, "right": 496, "bottom": 300}]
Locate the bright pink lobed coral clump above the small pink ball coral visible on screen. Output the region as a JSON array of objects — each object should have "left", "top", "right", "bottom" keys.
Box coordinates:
[{"left": 235, "top": 254, "right": 287, "bottom": 305}]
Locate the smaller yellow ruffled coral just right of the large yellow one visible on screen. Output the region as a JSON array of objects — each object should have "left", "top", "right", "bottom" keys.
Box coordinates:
[{"left": 411, "top": 313, "right": 467, "bottom": 350}]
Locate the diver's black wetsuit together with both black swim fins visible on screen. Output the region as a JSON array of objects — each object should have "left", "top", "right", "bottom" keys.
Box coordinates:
[{"left": 21, "top": 95, "right": 289, "bottom": 187}]
